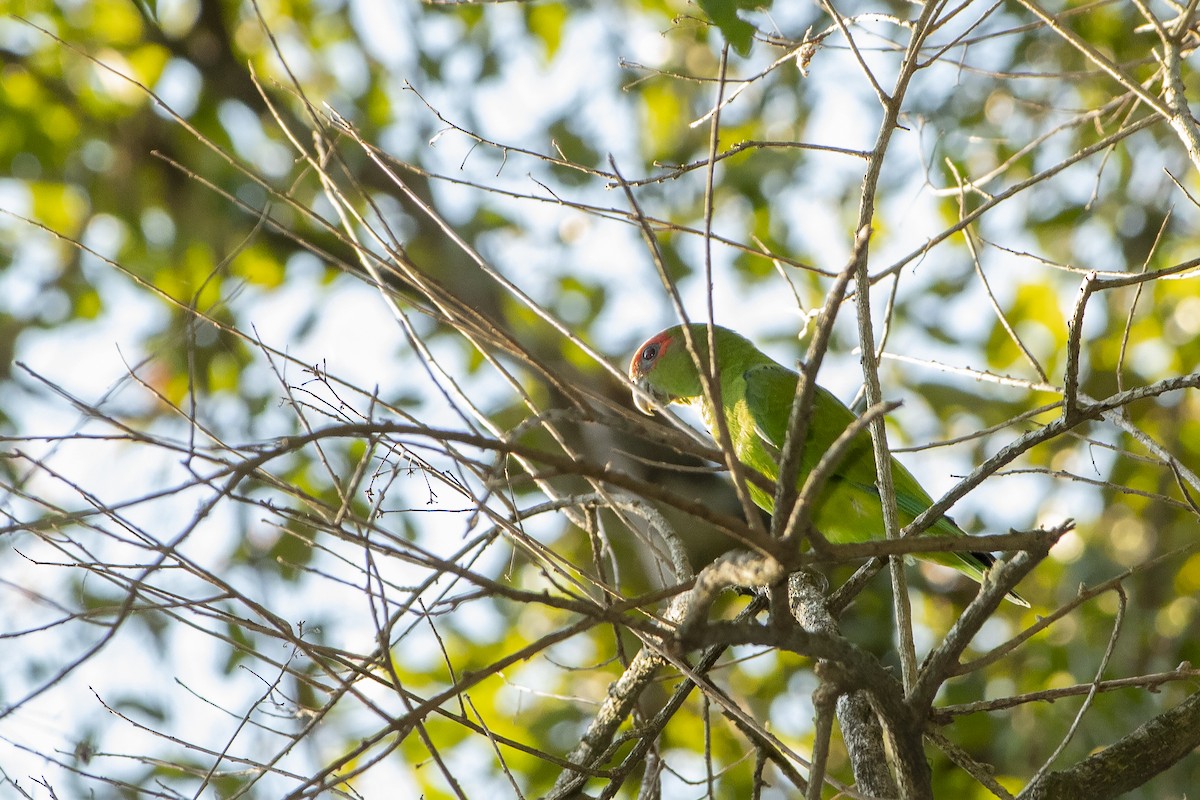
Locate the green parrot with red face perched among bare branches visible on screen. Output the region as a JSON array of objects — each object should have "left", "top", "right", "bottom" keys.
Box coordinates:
[{"left": 629, "top": 324, "right": 1028, "bottom": 607}]
